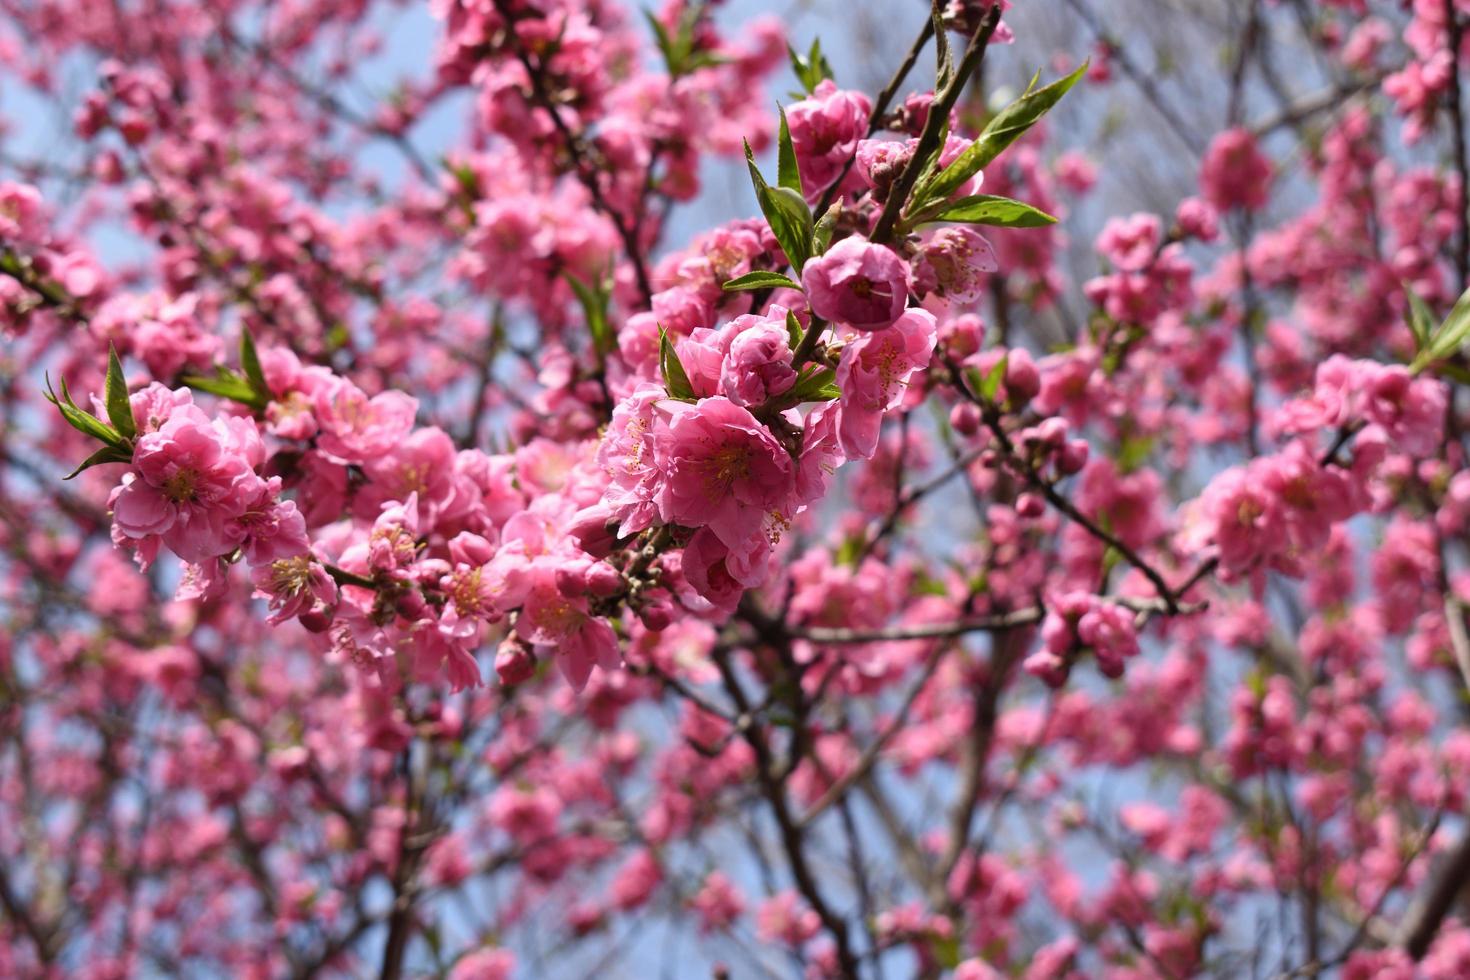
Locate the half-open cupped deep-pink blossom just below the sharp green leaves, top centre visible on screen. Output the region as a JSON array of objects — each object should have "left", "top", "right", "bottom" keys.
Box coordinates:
[{"left": 801, "top": 235, "right": 908, "bottom": 331}]
